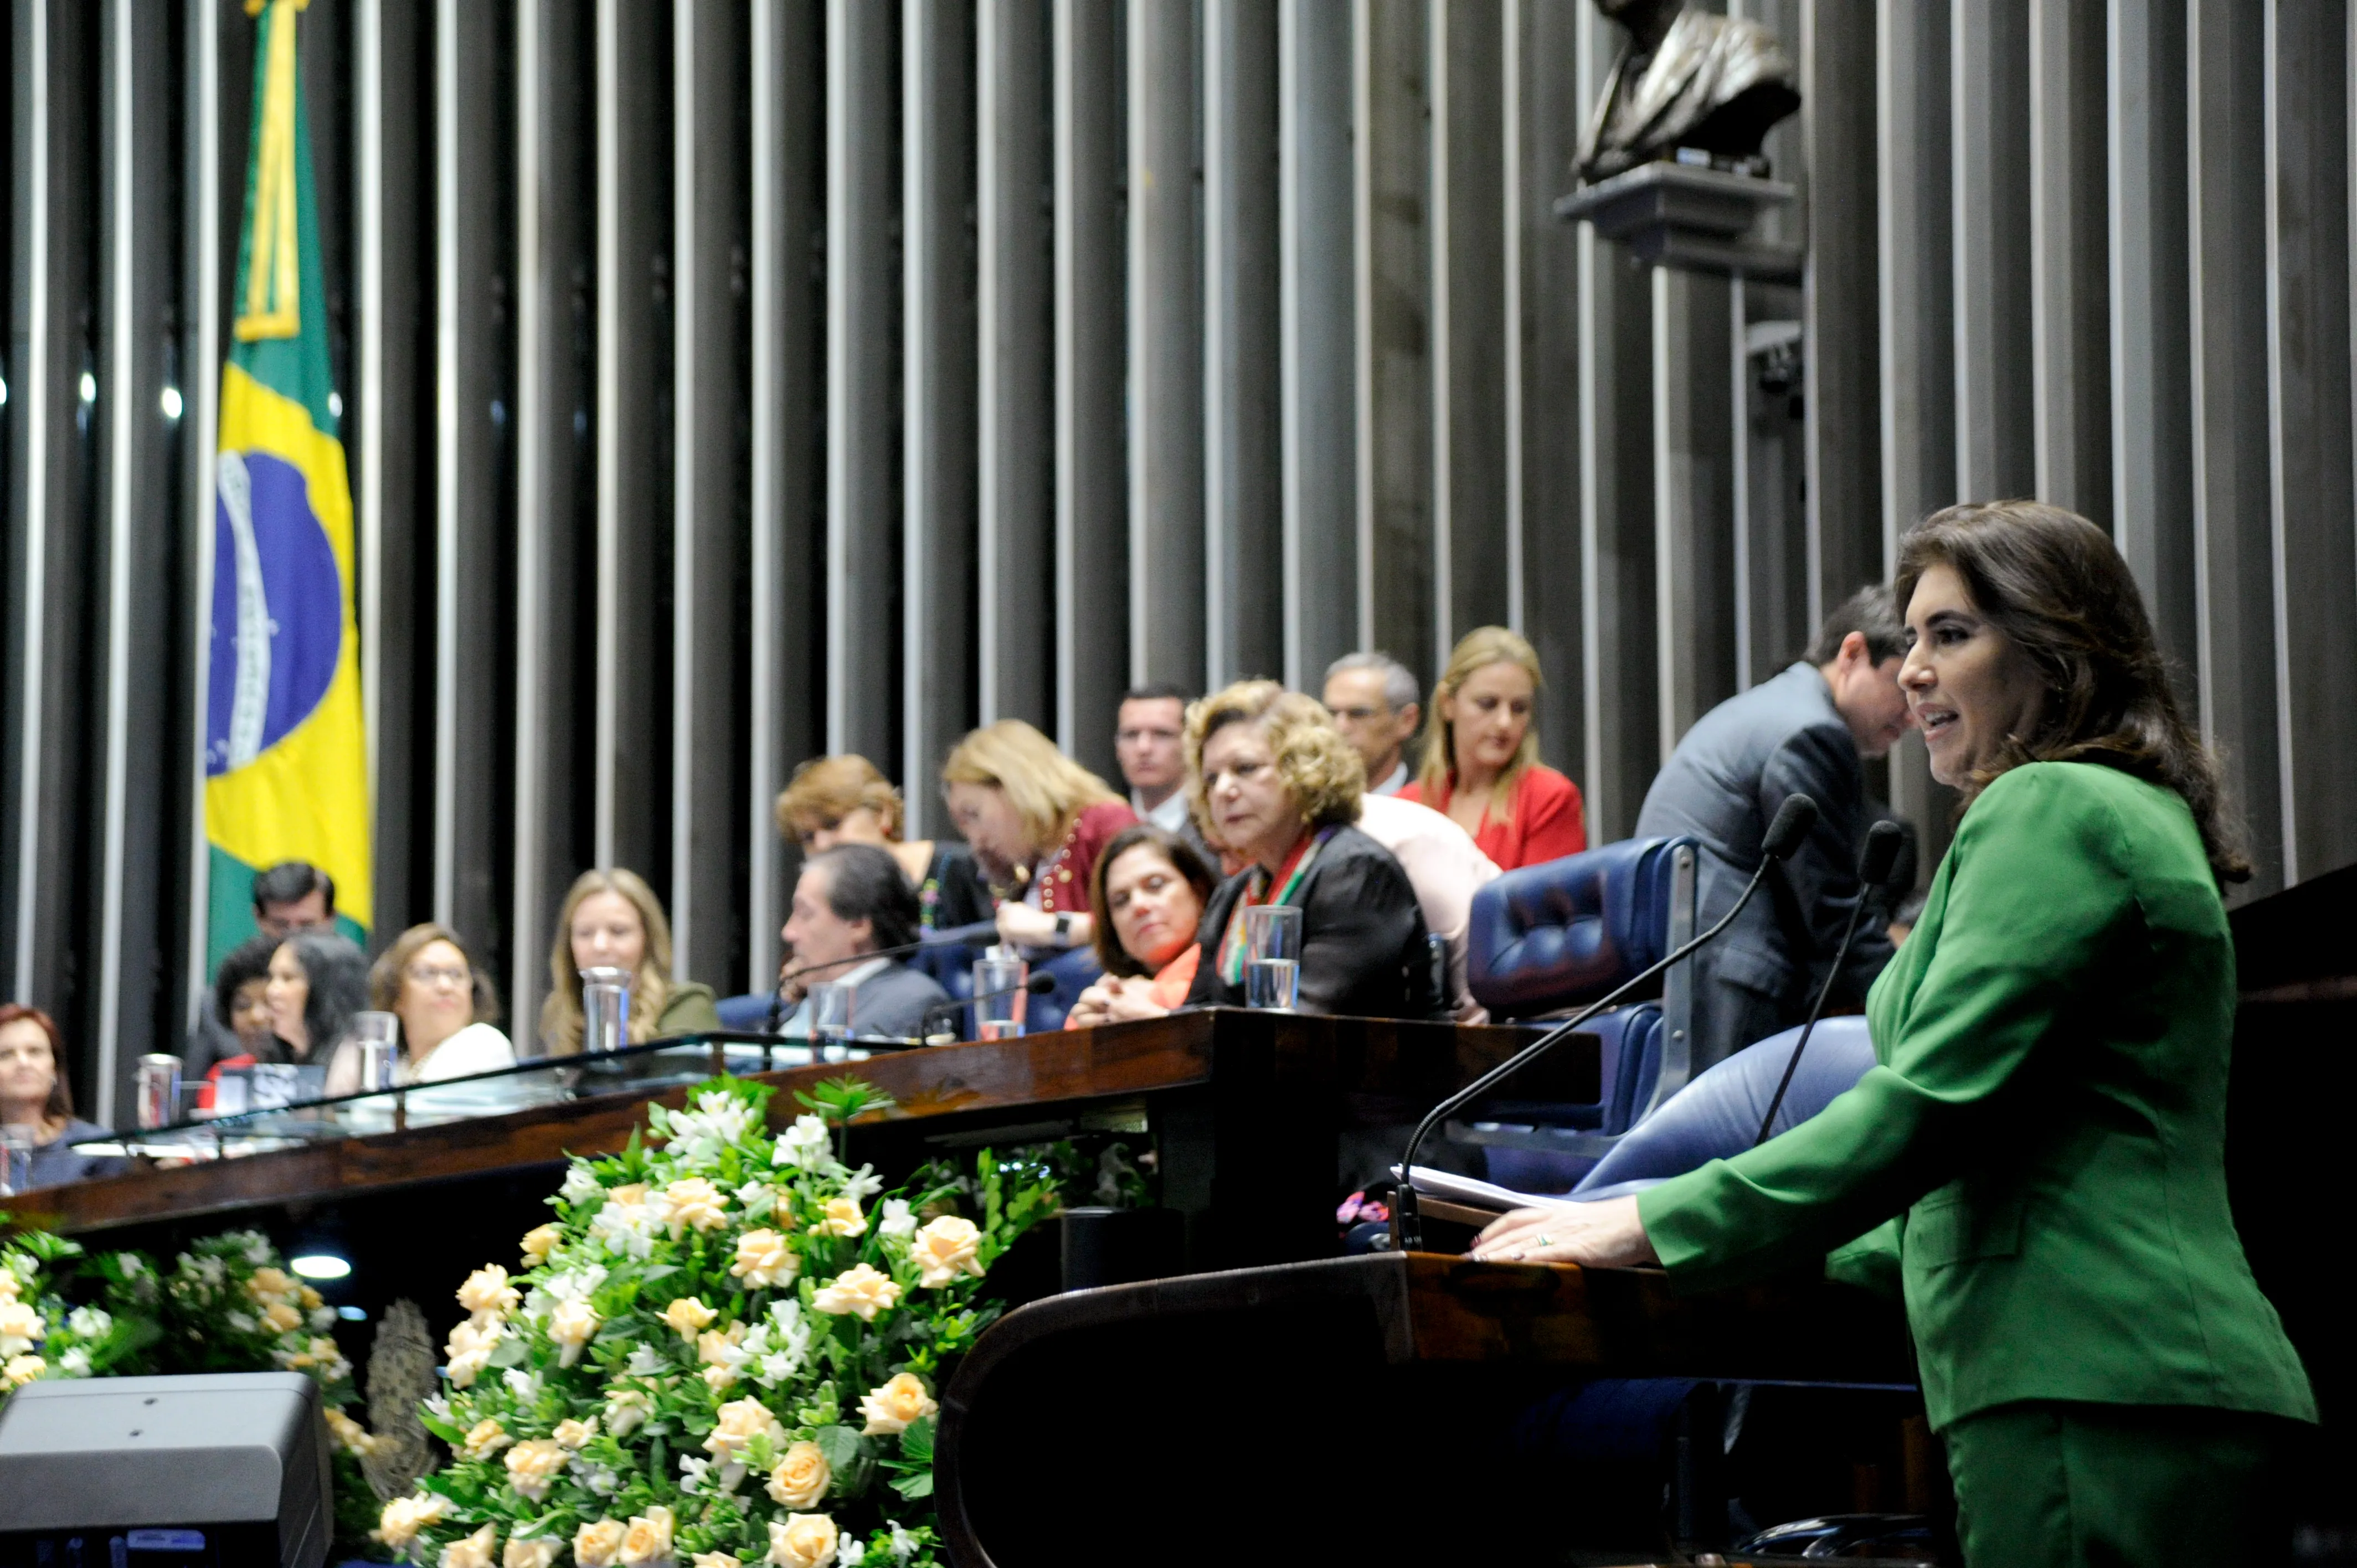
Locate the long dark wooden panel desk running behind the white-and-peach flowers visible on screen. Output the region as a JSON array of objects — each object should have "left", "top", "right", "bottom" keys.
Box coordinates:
[{"left": 9, "top": 1009, "right": 1598, "bottom": 1282}]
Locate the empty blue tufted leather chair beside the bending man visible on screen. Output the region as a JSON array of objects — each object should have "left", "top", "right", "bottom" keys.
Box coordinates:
[{"left": 1447, "top": 837, "right": 1695, "bottom": 1193}]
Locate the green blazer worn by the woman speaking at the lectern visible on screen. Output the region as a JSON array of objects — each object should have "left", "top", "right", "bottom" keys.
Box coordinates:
[{"left": 1638, "top": 762, "right": 2317, "bottom": 1426}]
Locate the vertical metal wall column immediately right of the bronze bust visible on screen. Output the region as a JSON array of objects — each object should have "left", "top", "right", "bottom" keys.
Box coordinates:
[{"left": 1801, "top": 0, "right": 1876, "bottom": 632}]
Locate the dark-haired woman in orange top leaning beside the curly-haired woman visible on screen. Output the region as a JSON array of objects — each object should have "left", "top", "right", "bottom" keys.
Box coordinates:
[{"left": 1063, "top": 823, "right": 1218, "bottom": 1028}]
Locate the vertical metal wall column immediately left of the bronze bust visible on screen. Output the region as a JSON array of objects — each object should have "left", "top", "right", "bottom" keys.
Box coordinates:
[{"left": 1501, "top": 0, "right": 1589, "bottom": 776}]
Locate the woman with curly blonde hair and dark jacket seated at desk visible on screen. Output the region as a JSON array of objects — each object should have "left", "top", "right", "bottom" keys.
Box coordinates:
[{"left": 1186, "top": 682, "right": 1445, "bottom": 1019}]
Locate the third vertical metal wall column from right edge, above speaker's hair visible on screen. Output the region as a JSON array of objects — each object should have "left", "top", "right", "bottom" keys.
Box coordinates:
[{"left": 2105, "top": 0, "right": 2197, "bottom": 700}]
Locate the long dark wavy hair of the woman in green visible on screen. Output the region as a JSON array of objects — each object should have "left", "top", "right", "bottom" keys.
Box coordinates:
[{"left": 1893, "top": 500, "right": 2251, "bottom": 884}]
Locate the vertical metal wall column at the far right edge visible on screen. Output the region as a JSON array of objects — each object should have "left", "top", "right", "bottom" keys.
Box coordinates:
[{"left": 2267, "top": 0, "right": 2357, "bottom": 882}]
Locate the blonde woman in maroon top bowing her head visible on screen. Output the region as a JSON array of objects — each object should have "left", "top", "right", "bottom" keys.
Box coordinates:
[{"left": 940, "top": 719, "right": 1139, "bottom": 948}]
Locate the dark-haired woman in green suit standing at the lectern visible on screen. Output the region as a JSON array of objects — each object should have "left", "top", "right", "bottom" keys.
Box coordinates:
[{"left": 1475, "top": 502, "right": 2317, "bottom": 1568}]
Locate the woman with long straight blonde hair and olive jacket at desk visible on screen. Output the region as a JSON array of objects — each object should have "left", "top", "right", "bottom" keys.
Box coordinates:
[{"left": 540, "top": 865, "right": 721, "bottom": 1056}]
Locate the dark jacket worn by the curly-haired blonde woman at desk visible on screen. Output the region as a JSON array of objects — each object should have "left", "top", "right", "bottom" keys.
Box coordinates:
[{"left": 1186, "top": 828, "right": 1447, "bottom": 1019}]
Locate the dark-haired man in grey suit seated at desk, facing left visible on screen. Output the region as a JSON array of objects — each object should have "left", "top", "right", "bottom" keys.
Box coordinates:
[{"left": 785, "top": 844, "right": 950, "bottom": 1040}]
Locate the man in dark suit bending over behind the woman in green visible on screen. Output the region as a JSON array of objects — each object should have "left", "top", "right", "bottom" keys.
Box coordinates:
[{"left": 1636, "top": 587, "right": 1907, "bottom": 1073}]
